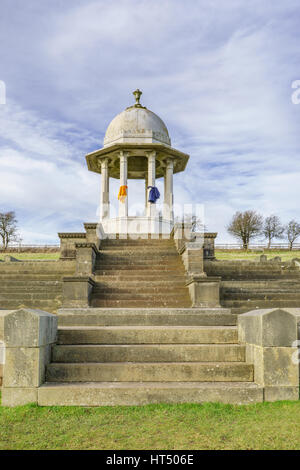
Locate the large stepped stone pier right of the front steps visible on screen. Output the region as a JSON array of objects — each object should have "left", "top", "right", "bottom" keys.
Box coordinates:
[{"left": 238, "top": 308, "right": 299, "bottom": 401}]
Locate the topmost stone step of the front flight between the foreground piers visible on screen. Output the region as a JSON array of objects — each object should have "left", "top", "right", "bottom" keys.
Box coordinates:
[{"left": 57, "top": 308, "right": 237, "bottom": 326}]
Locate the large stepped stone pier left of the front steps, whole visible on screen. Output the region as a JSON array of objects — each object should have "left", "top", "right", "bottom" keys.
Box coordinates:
[{"left": 2, "top": 309, "right": 57, "bottom": 406}]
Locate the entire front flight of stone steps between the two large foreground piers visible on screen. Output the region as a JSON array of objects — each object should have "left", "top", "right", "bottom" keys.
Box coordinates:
[{"left": 38, "top": 308, "right": 263, "bottom": 406}]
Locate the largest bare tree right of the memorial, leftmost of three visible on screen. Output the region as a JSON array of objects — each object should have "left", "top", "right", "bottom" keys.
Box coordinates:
[{"left": 227, "top": 210, "right": 263, "bottom": 250}]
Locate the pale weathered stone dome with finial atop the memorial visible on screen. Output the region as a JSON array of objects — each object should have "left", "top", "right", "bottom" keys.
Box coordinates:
[{"left": 103, "top": 90, "right": 171, "bottom": 147}]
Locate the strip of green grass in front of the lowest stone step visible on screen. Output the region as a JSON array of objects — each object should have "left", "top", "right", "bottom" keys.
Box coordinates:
[{"left": 0, "top": 401, "right": 300, "bottom": 450}]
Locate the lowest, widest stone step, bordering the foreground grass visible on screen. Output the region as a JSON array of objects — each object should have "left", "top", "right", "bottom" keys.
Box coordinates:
[{"left": 38, "top": 382, "right": 263, "bottom": 406}]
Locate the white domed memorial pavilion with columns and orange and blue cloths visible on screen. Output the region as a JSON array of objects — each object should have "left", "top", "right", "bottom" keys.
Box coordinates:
[{"left": 86, "top": 89, "right": 189, "bottom": 234}]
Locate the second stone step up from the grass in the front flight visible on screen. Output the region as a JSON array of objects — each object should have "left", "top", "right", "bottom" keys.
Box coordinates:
[{"left": 46, "top": 362, "right": 253, "bottom": 382}]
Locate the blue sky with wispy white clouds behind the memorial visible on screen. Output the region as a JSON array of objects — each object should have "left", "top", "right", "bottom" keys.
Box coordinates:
[{"left": 0, "top": 0, "right": 300, "bottom": 244}]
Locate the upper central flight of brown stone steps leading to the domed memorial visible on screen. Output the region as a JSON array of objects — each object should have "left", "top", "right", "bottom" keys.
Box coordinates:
[{"left": 91, "top": 239, "right": 191, "bottom": 308}]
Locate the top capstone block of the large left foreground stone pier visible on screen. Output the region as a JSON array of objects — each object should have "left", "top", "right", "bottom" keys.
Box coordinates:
[{"left": 3, "top": 309, "right": 57, "bottom": 348}]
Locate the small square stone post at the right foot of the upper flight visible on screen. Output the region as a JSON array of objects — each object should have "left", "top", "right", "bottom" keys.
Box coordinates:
[{"left": 186, "top": 275, "right": 221, "bottom": 308}]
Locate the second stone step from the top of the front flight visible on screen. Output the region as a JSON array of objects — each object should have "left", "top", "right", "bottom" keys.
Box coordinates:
[{"left": 58, "top": 325, "right": 238, "bottom": 345}]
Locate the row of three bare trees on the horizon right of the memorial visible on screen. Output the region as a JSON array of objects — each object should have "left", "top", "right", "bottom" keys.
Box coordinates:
[{"left": 226, "top": 210, "right": 300, "bottom": 250}]
